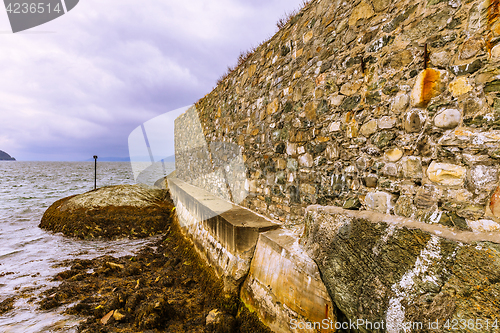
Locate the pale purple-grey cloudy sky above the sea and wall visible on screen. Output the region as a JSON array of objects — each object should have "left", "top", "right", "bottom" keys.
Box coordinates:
[{"left": 0, "top": 0, "right": 302, "bottom": 161}]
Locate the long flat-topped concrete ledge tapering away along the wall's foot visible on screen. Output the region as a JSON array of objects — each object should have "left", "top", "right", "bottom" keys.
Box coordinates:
[{"left": 168, "top": 178, "right": 279, "bottom": 292}]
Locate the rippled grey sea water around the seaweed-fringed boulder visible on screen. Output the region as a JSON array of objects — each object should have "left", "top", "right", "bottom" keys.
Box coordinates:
[{"left": 0, "top": 161, "right": 168, "bottom": 333}]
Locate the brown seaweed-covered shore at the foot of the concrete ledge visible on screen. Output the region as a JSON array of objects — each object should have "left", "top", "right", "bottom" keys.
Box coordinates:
[{"left": 39, "top": 187, "right": 270, "bottom": 333}]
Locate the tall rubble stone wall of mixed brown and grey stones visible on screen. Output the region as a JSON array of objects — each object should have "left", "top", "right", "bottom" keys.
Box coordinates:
[{"left": 176, "top": 0, "right": 500, "bottom": 231}]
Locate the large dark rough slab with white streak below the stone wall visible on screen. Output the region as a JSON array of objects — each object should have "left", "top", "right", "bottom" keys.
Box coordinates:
[{"left": 304, "top": 206, "right": 500, "bottom": 332}]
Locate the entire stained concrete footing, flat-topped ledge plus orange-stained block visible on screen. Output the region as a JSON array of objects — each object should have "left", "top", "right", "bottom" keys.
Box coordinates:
[{"left": 168, "top": 178, "right": 335, "bottom": 332}]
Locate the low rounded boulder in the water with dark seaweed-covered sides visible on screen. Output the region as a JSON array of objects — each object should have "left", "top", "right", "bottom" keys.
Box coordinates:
[{"left": 39, "top": 185, "right": 174, "bottom": 239}]
